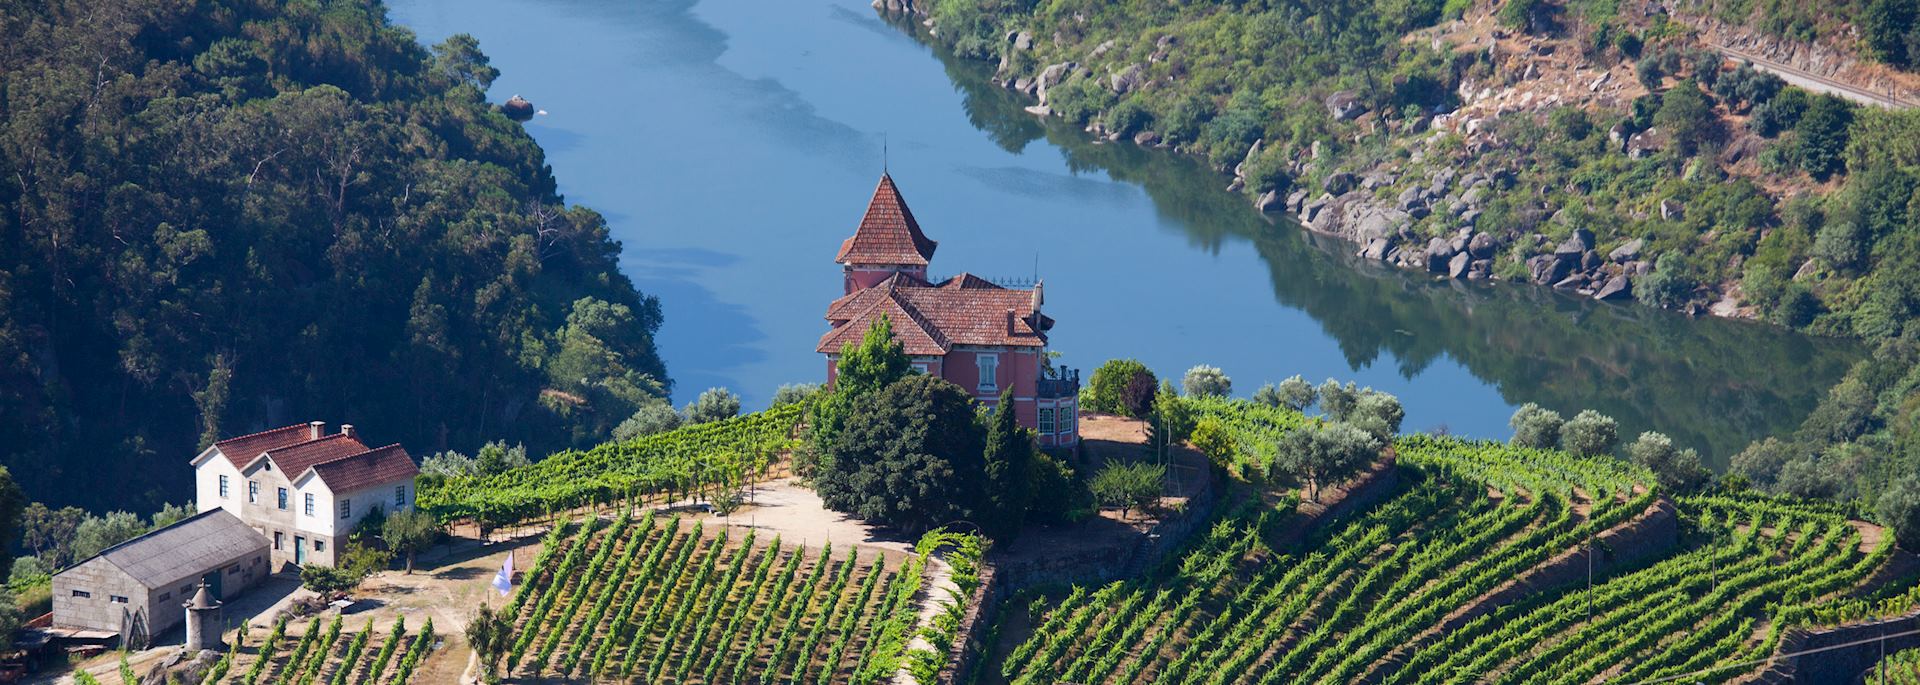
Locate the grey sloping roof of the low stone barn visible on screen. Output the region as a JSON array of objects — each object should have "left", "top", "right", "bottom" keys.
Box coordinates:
[{"left": 75, "top": 506, "right": 270, "bottom": 589}]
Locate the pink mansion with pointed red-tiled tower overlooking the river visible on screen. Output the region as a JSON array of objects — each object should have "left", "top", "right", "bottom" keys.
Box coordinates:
[{"left": 814, "top": 175, "right": 1079, "bottom": 447}]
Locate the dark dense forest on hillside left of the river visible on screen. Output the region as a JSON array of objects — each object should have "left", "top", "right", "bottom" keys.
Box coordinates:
[{"left": 0, "top": 0, "right": 670, "bottom": 510}]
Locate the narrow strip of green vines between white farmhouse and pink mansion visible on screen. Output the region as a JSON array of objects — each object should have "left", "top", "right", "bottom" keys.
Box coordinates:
[{"left": 417, "top": 405, "right": 803, "bottom": 524}]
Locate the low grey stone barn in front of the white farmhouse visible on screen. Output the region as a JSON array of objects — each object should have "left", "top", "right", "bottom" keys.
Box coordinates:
[{"left": 54, "top": 508, "right": 269, "bottom": 647}]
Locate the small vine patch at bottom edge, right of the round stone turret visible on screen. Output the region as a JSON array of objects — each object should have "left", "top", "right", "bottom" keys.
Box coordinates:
[{"left": 205, "top": 616, "right": 436, "bottom": 685}]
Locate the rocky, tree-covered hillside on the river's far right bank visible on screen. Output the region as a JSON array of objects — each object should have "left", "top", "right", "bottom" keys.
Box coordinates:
[{"left": 910, "top": 0, "right": 1920, "bottom": 516}]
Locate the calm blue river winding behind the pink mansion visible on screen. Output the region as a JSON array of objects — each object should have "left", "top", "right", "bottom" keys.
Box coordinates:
[{"left": 390, "top": 0, "right": 1860, "bottom": 468}]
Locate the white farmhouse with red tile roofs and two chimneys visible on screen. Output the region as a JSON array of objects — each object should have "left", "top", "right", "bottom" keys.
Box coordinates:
[{"left": 192, "top": 420, "right": 420, "bottom": 568}]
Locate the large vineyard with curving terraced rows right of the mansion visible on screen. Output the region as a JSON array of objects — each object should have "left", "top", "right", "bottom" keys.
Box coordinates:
[{"left": 983, "top": 403, "right": 1889, "bottom": 685}]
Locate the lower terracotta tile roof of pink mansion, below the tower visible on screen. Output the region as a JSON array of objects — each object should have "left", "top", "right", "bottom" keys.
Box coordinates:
[{"left": 814, "top": 274, "right": 1052, "bottom": 357}]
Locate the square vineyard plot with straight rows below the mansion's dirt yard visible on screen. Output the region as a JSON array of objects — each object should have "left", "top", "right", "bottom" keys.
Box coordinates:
[{"left": 505, "top": 512, "right": 922, "bottom": 685}]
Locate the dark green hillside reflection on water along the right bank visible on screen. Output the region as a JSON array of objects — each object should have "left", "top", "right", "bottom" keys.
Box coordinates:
[{"left": 897, "top": 16, "right": 1860, "bottom": 468}]
